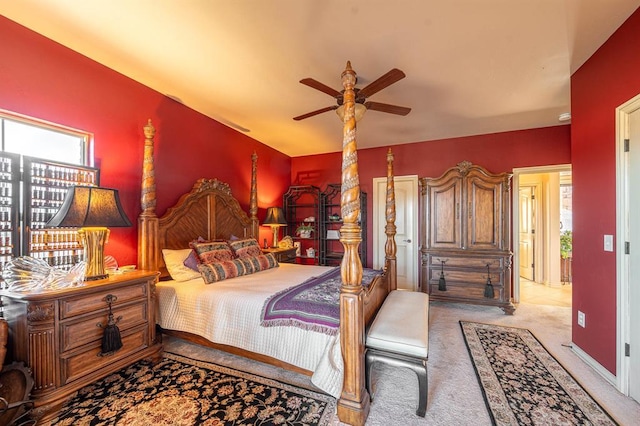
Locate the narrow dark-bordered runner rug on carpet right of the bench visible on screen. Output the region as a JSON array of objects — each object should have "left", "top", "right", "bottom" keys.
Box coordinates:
[{"left": 460, "top": 321, "right": 616, "bottom": 425}]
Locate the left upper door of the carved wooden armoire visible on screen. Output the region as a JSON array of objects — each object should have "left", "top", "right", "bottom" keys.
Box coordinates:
[{"left": 426, "top": 176, "right": 463, "bottom": 249}]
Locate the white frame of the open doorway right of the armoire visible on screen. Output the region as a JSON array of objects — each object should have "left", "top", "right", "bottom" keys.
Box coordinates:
[{"left": 511, "top": 164, "right": 573, "bottom": 302}]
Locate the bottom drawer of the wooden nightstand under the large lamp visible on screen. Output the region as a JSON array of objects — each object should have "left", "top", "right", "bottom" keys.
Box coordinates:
[{"left": 60, "top": 325, "right": 149, "bottom": 385}]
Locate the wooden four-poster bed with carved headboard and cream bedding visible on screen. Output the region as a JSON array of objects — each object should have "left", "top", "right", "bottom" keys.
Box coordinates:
[{"left": 138, "top": 64, "right": 396, "bottom": 424}]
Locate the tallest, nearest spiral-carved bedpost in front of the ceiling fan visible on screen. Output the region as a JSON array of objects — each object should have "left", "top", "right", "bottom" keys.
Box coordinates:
[{"left": 338, "top": 62, "right": 370, "bottom": 425}]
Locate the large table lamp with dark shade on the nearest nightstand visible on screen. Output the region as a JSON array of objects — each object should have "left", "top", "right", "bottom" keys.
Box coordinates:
[{"left": 46, "top": 186, "right": 131, "bottom": 281}]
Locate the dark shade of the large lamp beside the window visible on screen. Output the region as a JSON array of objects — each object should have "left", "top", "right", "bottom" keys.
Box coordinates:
[{"left": 46, "top": 186, "right": 131, "bottom": 228}]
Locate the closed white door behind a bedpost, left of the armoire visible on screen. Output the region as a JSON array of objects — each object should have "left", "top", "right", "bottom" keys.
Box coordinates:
[{"left": 373, "top": 175, "right": 420, "bottom": 291}]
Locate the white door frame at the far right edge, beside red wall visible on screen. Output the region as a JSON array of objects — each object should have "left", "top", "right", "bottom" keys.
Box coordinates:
[{"left": 616, "top": 91, "right": 640, "bottom": 395}]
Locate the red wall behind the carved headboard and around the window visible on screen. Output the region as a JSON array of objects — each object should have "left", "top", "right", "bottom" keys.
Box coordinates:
[{"left": 0, "top": 16, "right": 290, "bottom": 264}]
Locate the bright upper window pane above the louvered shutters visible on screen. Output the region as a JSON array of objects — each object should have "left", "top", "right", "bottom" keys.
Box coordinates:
[{"left": 0, "top": 111, "right": 93, "bottom": 166}]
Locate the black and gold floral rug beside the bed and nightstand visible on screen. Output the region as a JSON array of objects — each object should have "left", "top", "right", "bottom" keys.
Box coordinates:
[{"left": 52, "top": 352, "right": 336, "bottom": 426}]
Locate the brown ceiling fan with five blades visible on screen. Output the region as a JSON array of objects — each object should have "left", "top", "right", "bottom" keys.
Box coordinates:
[{"left": 293, "top": 62, "right": 411, "bottom": 121}]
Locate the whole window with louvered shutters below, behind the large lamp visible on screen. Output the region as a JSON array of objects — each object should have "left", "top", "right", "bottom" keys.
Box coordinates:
[{"left": 0, "top": 110, "right": 99, "bottom": 270}]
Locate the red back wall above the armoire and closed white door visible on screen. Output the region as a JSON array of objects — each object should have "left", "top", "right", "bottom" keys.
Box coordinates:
[{"left": 291, "top": 125, "right": 571, "bottom": 265}]
